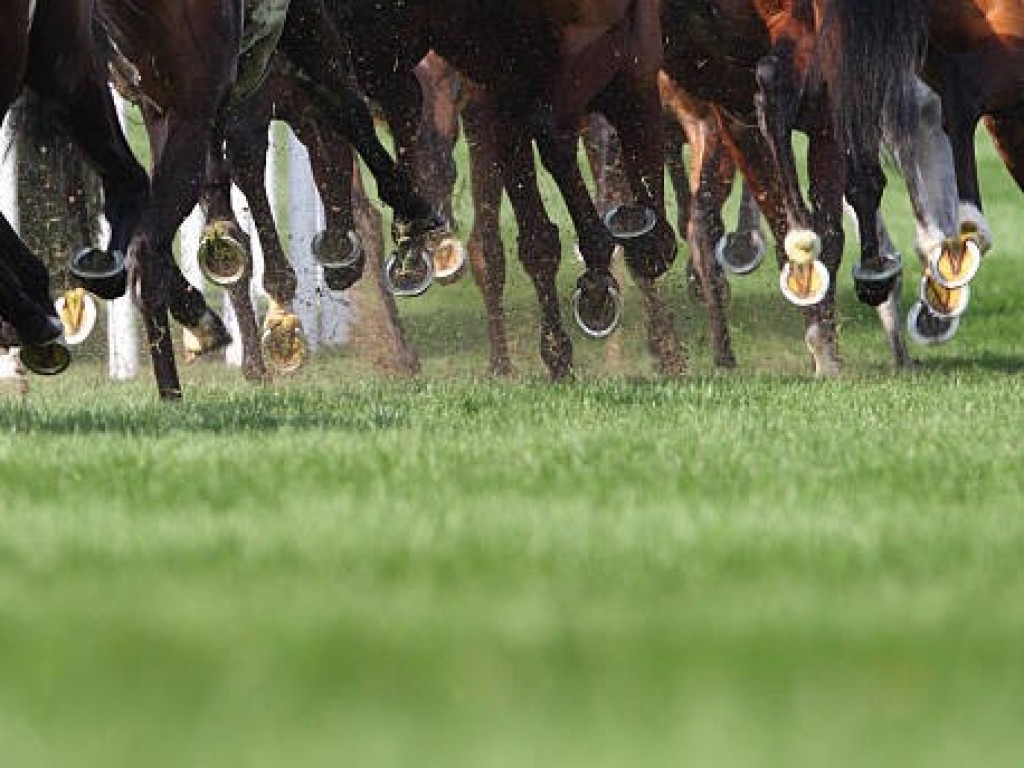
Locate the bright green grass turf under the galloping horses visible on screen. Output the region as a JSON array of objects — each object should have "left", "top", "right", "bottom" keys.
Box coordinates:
[{"left": 0, "top": 132, "right": 1024, "bottom": 768}]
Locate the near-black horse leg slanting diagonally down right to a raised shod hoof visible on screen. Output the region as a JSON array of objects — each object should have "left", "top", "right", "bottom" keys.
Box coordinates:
[{"left": 280, "top": 0, "right": 442, "bottom": 237}]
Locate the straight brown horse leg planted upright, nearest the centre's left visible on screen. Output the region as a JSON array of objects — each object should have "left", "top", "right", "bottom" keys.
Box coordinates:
[{"left": 462, "top": 86, "right": 516, "bottom": 376}]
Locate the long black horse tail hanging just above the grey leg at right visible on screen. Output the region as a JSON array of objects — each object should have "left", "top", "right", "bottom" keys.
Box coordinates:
[{"left": 814, "top": 0, "right": 929, "bottom": 153}]
